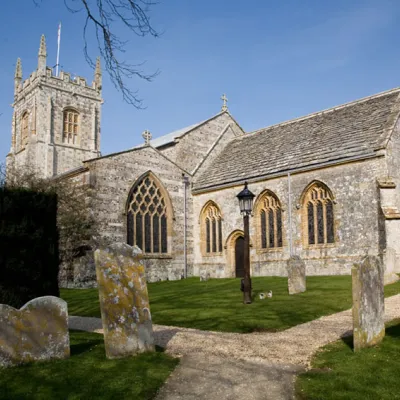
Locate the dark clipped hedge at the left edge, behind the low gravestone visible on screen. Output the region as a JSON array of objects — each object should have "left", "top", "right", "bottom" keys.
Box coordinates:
[{"left": 0, "top": 187, "right": 59, "bottom": 308}]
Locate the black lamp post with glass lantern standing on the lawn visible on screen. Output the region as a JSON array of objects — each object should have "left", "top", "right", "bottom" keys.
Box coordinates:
[{"left": 236, "top": 182, "right": 255, "bottom": 304}]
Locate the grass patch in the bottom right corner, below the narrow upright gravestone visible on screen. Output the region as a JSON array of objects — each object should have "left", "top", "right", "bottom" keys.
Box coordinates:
[{"left": 296, "top": 320, "right": 400, "bottom": 400}]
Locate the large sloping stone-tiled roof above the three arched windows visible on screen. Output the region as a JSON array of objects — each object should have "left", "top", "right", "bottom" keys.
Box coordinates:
[{"left": 193, "top": 88, "right": 400, "bottom": 191}]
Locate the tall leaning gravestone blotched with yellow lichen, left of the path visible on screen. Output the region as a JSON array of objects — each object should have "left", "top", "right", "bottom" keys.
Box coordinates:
[{"left": 95, "top": 243, "right": 154, "bottom": 358}]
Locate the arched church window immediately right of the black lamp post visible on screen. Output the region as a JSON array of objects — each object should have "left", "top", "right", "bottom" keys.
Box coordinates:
[{"left": 255, "top": 191, "right": 283, "bottom": 249}]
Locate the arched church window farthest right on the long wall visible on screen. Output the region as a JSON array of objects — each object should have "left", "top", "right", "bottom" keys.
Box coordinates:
[{"left": 303, "top": 182, "right": 335, "bottom": 246}]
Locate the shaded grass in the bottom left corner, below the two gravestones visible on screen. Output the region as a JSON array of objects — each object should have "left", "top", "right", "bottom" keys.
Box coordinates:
[{"left": 0, "top": 331, "right": 178, "bottom": 400}]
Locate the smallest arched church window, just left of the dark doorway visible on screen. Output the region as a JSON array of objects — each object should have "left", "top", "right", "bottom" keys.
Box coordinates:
[{"left": 201, "top": 202, "right": 222, "bottom": 255}]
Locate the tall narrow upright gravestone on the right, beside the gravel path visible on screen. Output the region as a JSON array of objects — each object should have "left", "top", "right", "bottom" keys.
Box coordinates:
[{"left": 351, "top": 256, "right": 385, "bottom": 351}]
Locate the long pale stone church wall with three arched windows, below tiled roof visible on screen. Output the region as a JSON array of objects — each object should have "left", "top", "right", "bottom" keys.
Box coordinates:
[{"left": 193, "top": 157, "right": 386, "bottom": 277}]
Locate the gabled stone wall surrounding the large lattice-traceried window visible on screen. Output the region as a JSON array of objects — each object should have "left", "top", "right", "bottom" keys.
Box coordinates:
[{"left": 85, "top": 147, "right": 193, "bottom": 281}]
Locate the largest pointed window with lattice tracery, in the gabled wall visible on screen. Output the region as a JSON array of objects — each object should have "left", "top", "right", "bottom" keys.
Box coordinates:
[{"left": 127, "top": 175, "right": 168, "bottom": 254}]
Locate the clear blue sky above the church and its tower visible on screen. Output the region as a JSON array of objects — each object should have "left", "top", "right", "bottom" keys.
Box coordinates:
[{"left": 0, "top": 0, "right": 400, "bottom": 162}]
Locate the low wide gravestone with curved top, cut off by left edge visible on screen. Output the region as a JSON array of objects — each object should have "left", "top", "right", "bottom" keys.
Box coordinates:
[{"left": 0, "top": 296, "right": 70, "bottom": 367}]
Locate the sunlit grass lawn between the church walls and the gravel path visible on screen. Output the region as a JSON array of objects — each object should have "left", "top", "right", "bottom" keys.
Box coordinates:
[{"left": 61, "top": 276, "right": 400, "bottom": 332}]
